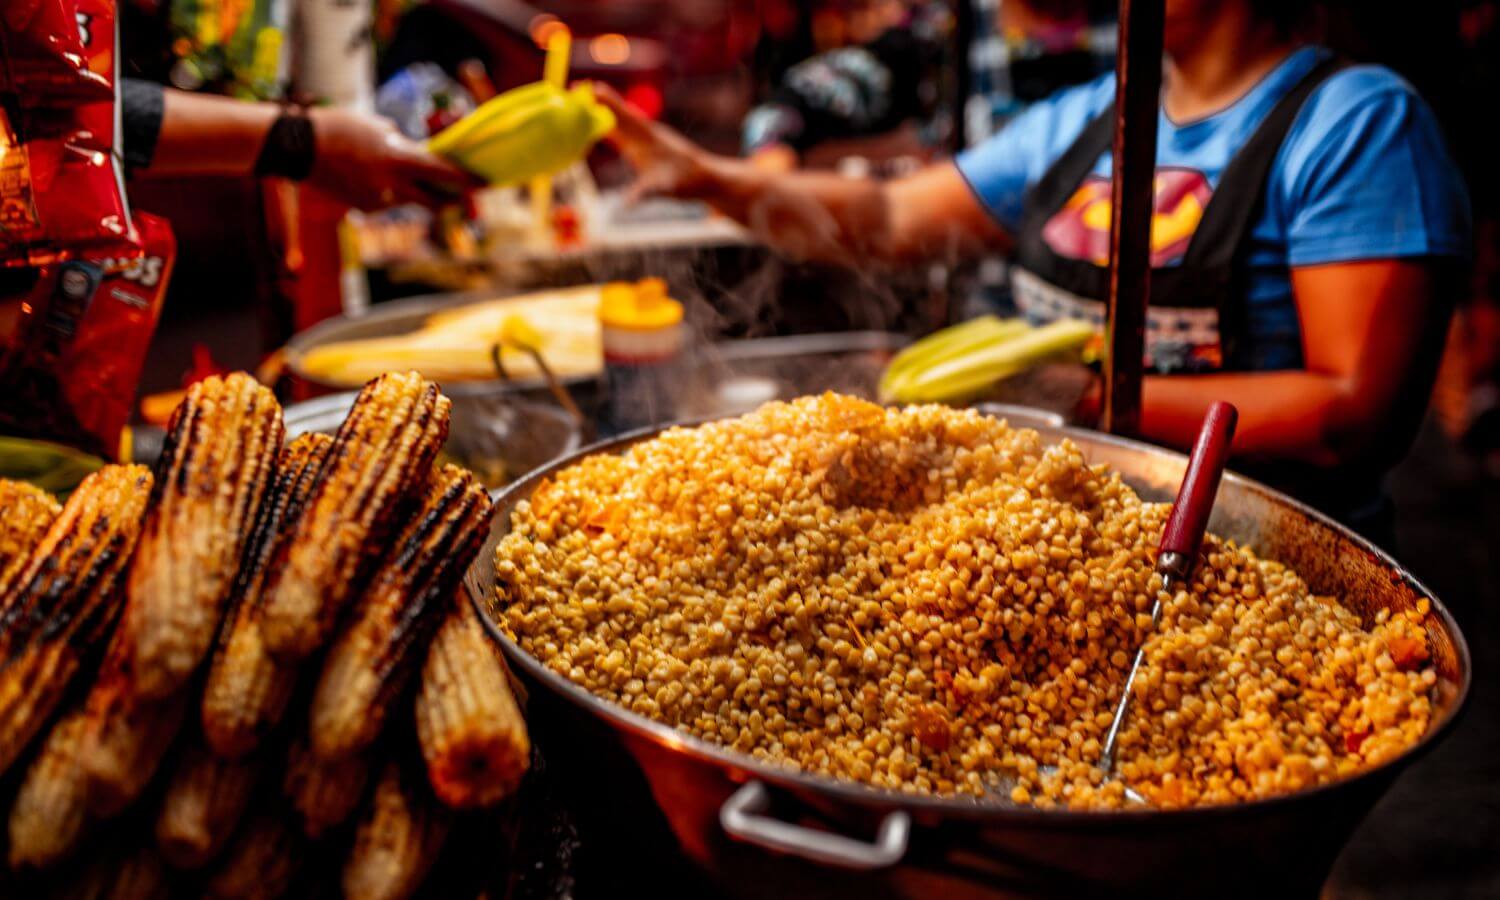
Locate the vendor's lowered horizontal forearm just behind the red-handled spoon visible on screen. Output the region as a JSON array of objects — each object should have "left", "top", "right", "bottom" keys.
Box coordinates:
[{"left": 1142, "top": 372, "right": 1364, "bottom": 465}]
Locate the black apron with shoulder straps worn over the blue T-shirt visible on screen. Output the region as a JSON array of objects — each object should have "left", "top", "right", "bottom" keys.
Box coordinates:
[{"left": 1011, "top": 57, "right": 1394, "bottom": 546}]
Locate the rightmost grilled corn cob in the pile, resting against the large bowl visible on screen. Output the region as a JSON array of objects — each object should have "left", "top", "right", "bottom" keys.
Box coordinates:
[{"left": 417, "top": 597, "right": 531, "bottom": 809}]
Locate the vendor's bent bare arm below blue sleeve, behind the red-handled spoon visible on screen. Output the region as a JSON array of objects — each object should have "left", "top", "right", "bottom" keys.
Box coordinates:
[{"left": 1142, "top": 260, "right": 1454, "bottom": 465}]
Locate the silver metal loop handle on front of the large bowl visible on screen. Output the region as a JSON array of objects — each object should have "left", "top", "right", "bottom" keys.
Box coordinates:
[{"left": 719, "top": 782, "right": 912, "bottom": 870}]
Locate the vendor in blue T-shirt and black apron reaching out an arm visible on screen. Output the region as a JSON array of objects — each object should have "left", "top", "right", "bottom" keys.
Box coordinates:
[{"left": 603, "top": 0, "right": 1470, "bottom": 528}]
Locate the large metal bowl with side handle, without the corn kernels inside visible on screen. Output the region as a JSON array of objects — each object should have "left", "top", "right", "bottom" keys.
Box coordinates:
[{"left": 465, "top": 416, "right": 1470, "bottom": 897}]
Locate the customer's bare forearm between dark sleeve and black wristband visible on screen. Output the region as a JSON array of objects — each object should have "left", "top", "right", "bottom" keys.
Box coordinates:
[{"left": 146, "top": 90, "right": 281, "bottom": 176}]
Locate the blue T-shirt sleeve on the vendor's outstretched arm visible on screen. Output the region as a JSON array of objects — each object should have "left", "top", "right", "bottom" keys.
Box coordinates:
[{"left": 954, "top": 75, "right": 1115, "bottom": 234}]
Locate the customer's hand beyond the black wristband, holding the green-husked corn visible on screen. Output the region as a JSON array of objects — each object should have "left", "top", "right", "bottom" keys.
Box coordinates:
[{"left": 308, "top": 107, "right": 485, "bottom": 210}]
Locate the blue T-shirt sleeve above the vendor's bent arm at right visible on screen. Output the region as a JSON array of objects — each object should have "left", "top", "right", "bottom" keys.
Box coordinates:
[{"left": 1269, "top": 66, "right": 1470, "bottom": 266}]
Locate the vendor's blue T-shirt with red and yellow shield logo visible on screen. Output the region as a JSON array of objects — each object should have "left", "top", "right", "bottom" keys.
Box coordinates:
[{"left": 957, "top": 47, "right": 1470, "bottom": 369}]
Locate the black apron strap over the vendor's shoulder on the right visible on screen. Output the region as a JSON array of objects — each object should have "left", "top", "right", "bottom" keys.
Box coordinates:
[{"left": 1181, "top": 57, "right": 1349, "bottom": 269}]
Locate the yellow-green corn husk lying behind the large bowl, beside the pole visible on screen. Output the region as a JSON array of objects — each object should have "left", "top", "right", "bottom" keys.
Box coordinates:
[{"left": 891, "top": 320, "right": 1094, "bottom": 404}]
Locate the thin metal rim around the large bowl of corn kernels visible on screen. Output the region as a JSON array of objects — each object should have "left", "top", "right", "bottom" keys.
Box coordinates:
[{"left": 465, "top": 417, "right": 1473, "bottom": 828}]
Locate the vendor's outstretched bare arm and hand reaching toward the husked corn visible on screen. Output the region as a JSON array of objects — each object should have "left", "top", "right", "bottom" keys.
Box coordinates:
[{"left": 597, "top": 86, "right": 1008, "bottom": 266}]
